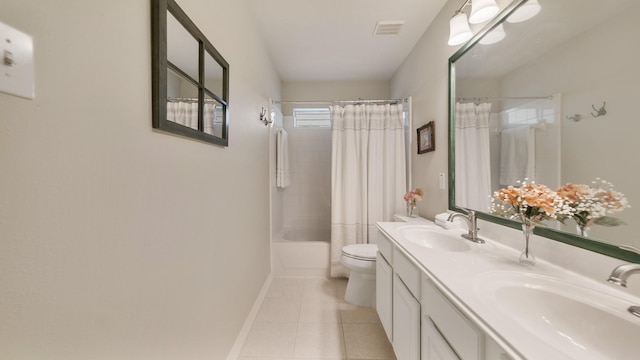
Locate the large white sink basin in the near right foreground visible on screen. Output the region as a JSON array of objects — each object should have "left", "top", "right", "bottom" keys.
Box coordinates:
[{"left": 475, "top": 272, "right": 640, "bottom": 359}]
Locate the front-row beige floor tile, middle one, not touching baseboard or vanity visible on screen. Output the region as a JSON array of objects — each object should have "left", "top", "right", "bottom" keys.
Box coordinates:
[{"left": 293, "top": 323, "right": 345, "bottom": 359}]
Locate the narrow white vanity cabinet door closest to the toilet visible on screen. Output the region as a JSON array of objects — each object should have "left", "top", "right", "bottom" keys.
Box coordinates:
[{"left": 376, "top": 252, "right": 393, "bottom": 341}]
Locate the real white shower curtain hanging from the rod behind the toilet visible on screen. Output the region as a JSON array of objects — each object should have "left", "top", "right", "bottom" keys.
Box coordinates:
[{"left": 331, "top": 105, "right": 406, "bottom": 277}]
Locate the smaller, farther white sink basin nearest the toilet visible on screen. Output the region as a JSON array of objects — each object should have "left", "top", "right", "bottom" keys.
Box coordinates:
[{"left": 399, "top": 226, "right": 471, "bottom": 251}]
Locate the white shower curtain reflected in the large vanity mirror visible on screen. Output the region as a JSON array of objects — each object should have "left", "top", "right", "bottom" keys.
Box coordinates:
[{"left": 455, "top": 103, "right": 491, "bottom": 211}]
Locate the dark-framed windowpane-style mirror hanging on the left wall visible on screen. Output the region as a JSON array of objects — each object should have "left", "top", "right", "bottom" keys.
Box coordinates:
[{"left": 151, "top": 0, "right": 229, "bottom": 146}]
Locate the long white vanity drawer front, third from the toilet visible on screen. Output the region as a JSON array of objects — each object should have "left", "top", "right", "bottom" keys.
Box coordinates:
[{"left": 422, "top": 279, "right": 484, "bottom": 360}]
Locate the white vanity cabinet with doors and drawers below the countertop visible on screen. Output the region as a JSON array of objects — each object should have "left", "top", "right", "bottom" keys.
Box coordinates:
[{"left": 376, "top": 228, "right": 513, "bottom": 360}]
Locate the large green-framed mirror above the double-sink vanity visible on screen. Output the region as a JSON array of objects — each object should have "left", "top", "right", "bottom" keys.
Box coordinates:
[{"left": 449, "top": 0, "right": 640, "bottom": 262}]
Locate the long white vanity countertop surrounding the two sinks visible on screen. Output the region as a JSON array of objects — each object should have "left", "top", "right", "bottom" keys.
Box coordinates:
[{"left": 377, "top": 219, "right": 640, "bottom": 360}]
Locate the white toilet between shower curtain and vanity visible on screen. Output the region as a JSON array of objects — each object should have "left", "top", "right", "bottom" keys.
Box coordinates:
[{"left": 340, "top": 244, "right": 378, "bottom": 307}]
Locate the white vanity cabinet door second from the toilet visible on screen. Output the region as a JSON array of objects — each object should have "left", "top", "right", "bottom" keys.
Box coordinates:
[{"left": 393, "top": 274, "right": 420, "bottom": 360}]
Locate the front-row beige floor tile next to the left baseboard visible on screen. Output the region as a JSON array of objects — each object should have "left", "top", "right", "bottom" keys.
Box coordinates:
[{"left": 240, "top": 322, "right": 298, "bottom": 359}]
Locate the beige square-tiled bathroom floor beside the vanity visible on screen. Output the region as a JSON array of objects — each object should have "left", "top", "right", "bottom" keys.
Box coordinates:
[{"left": 238, "top": 278, "right": 396, "bottom": 360}]
